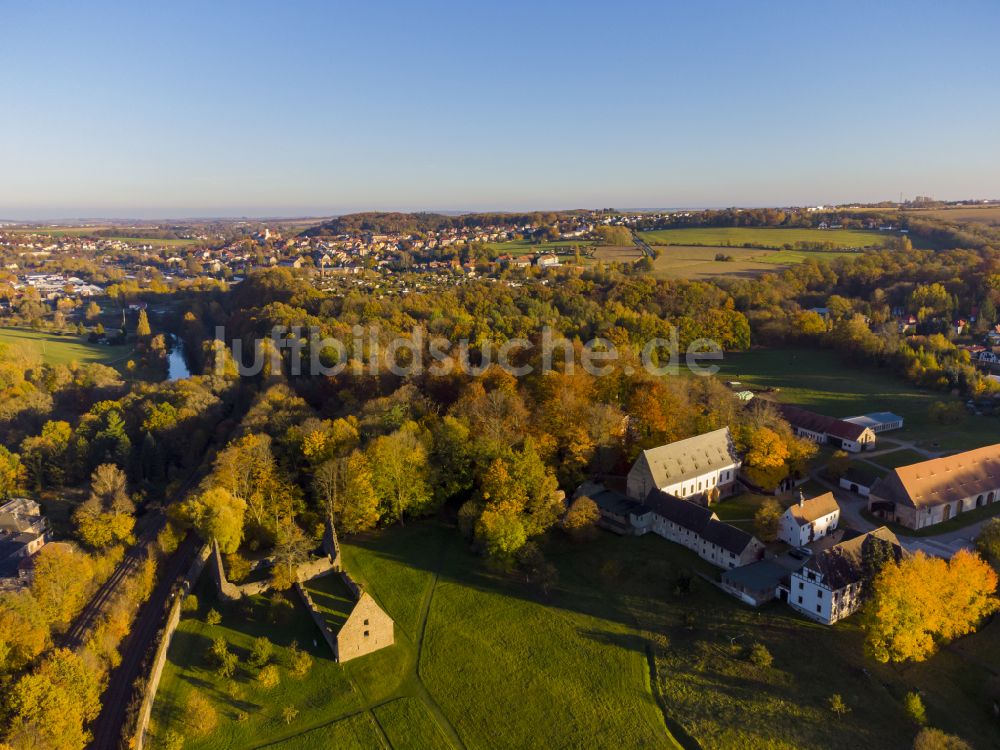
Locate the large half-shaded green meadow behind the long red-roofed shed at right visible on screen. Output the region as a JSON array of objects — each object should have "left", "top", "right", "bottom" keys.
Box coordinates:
[{"left": 719, "top": 349, "right": 1000, "bottom": 451}]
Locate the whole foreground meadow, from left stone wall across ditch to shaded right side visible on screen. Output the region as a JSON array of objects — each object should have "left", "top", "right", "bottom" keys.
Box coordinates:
[{"left": 152, "top": 524, "right": 1000, "bottom": 750}]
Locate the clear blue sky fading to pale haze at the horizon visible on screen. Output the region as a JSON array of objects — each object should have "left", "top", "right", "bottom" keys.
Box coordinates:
[{"left": 0, "top": 0, "right": 1000, "bottom": 218}]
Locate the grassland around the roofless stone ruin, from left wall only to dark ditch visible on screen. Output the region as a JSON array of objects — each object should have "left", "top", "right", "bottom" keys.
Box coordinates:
[{"left": 154, "top": 524, "right": 674, "bottom": 750}]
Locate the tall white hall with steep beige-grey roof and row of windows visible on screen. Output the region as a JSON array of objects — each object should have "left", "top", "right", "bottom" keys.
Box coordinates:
[{"left": 628, "top": 427, "right": 741, "bottom": 502}]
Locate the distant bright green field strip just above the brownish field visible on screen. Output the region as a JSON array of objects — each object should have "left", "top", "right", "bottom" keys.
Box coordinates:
[{"left": 639, "top": 227, "right": 894, "bottom": 249}]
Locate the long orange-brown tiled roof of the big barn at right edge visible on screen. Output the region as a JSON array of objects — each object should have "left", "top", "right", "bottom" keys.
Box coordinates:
[{"left": 871, "top": 443, "right": 1000, "bottom": 508}]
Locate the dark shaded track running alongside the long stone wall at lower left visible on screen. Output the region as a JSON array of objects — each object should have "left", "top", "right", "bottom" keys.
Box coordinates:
[{"left": 89, "top": 532, "right": 198, "bottom": 750}]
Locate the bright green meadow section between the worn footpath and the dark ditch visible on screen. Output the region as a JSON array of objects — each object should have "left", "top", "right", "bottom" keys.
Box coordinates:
[{"left": 420, "top": 539, "right": 669, "bottom": 748}]
